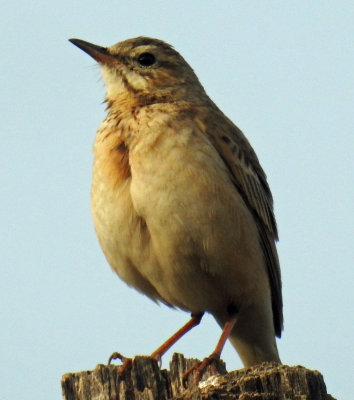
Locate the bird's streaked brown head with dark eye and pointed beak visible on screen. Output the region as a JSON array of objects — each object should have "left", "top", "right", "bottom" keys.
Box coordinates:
[{"left": 70, "top": 37, "right": 206, "bottom": 104}]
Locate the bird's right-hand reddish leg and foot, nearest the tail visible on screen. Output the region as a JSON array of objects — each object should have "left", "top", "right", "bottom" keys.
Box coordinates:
[{"left": 183, "top": 314, "right": 237, "bottom": 385}]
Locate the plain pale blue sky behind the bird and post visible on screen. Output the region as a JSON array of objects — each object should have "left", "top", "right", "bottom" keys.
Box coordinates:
[{"left": 0, "top": 0, "right": 354, "bottom": 400}]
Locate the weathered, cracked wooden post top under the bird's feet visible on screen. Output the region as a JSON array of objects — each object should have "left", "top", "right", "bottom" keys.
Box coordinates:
[{"left": 61, "top": 354, "right": 335, "bottom": 400}]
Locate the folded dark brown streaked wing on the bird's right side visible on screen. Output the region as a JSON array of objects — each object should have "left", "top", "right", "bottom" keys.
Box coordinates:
[{"left": 204, "top": 109, "right": 283, "bottom": 337}]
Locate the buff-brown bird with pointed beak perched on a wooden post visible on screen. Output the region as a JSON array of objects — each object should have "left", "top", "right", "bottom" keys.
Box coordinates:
[{"left": 69, "top": 36, "right": 283, "bottom": 380}]
